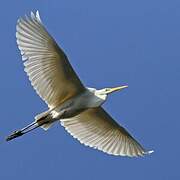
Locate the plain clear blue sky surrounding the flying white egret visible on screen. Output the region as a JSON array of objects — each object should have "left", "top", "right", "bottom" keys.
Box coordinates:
[{"left": 0, "top": 0, "right": 180, "bottom": 180}]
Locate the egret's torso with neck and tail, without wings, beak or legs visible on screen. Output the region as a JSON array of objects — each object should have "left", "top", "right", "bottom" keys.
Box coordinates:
[{"left": 36, "top": 87, "right": 110, "bottom": 130}]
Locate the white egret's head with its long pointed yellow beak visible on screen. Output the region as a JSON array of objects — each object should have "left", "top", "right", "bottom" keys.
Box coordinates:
[{"left": 95, "top": 86, "right": 128, "bottom": 100}]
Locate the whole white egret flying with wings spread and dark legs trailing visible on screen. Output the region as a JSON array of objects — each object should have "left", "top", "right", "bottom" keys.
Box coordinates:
[{"left": 6, "top": 11, "right": 153, "bottom": 157}]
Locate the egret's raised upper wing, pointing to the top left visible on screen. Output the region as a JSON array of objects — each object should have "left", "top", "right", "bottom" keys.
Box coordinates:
[{"left": 16, "top": 11, "right": 84, "bottom": 108}]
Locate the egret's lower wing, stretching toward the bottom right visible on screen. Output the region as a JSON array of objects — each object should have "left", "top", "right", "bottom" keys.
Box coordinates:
[{"left": 61, "top": 107, "right": 151, "bottom": 156}]
